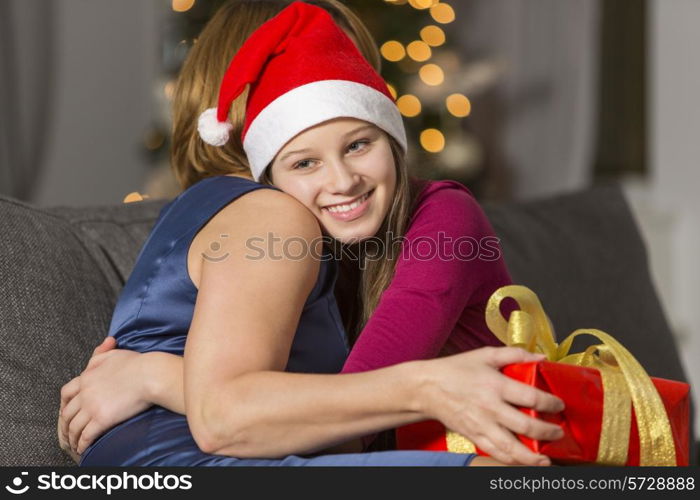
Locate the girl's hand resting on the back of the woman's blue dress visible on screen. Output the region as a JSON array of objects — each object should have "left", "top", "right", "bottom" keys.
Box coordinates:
[{"left": 59, "top": 337, "right": 151, "bottom": 458}]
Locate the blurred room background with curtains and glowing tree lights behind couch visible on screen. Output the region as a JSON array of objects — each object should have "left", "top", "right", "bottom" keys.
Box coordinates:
[{"left": 0, "top": 0, "right": 700, "bottom": 436}]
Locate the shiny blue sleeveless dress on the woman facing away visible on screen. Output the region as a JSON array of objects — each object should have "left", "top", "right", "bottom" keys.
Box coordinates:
[{"left": 80, "top": 176, "right": 474, "bottom": 467}]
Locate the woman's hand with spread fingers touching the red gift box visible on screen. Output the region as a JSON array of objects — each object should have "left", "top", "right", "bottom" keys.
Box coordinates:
[{"left": 424, "top": 347, "right": 564, "bottom": 465}]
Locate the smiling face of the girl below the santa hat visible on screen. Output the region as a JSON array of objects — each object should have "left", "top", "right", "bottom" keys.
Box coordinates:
[{"left": 269, "top": 118, "right": 396, "bottom": 243}]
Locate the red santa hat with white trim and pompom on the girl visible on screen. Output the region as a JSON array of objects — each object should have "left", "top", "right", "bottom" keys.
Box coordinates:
[{"left": 198, "top": 1, "right": 406, "bottom": 180}]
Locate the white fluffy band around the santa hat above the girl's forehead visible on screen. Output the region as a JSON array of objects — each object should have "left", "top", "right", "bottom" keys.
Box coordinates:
[{"left": 243, "top": 80, "right": 406, "bottom": 180}]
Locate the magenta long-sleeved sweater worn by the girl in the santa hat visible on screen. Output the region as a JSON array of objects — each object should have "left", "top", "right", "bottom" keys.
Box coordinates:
[{"left": 342, "top": 181, "right": 511, "bottom": 373}]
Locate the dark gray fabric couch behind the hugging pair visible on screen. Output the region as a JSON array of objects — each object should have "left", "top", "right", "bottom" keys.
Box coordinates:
[{"left": 0, "top": 185, "right": 695, "bottom": 465}]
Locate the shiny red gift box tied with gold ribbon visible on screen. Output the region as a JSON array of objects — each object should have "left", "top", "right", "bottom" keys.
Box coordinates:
[{"left": 396, "top": 361, "right": 689, "bottom": 465}]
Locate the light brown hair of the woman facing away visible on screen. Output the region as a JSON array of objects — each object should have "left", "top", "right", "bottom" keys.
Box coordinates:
[{"left": 170, "top": 0, "right": 381, "bottom": 190}]
